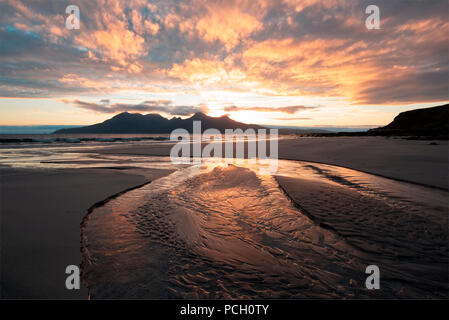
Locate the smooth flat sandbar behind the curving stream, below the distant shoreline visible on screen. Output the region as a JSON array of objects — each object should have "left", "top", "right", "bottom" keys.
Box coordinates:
[{"left": 80, "top": 137, "right": 449, "bottom": 190}]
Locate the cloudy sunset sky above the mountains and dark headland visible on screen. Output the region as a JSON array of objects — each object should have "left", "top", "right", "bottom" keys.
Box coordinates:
[{"left": 0, "top": 0, "right": 449, "bottom": 127}]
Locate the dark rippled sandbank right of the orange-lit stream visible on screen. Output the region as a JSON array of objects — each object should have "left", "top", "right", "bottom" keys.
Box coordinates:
[{"left": 276, "top": 176, "right": 449, "bottom": 298}]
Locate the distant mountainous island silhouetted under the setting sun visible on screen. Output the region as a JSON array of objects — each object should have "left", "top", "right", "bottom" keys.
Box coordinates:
[{"left": 54, "top": 112, "right": 263, "bottom": 134}]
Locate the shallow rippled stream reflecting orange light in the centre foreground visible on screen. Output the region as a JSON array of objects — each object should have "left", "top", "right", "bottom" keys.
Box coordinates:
[{"left": 83, "top": 166, "right": 357, "bottom": 299}]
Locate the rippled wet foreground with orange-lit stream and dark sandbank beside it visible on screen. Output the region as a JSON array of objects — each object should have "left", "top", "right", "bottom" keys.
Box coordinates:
[{"left": 83, "top": 160, "right": 447, "bottom": 298}]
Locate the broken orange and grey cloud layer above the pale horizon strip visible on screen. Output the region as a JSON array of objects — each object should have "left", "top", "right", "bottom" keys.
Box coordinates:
[{"left": 0, "top": 0, "right": 449, "bottom": 106}]
